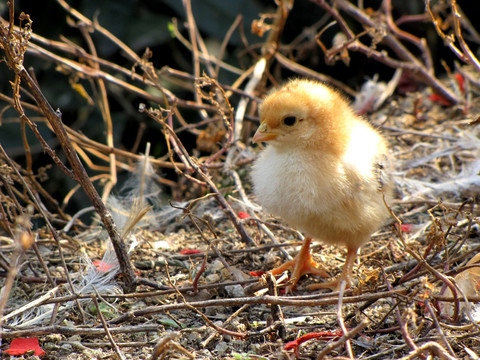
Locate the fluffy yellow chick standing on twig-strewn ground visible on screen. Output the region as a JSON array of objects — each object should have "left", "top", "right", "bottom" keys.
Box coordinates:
[{"left": 251, "top": 79, "right": 391, "bottom": 290}]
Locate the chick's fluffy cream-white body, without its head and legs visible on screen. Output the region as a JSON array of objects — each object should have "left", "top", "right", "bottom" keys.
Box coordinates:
[{"left": 252, "top": 123, "right": 386, "bottom": 242}]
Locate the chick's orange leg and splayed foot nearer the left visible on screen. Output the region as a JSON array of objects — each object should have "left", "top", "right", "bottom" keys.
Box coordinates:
[{"left": 269, "top": 238, "right": 330, "bottom": 292}]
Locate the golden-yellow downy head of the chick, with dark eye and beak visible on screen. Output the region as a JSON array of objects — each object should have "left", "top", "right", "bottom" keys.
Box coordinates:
[{"left": 253, "top": 79, "right": 355, "bottom": 152}]
